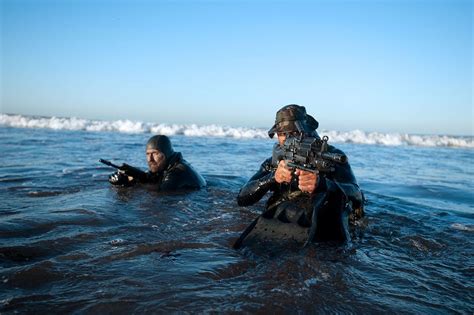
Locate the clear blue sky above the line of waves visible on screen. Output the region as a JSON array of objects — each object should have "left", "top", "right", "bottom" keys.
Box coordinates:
[{"left": 0, "top": 0, "right": 474, "bottom": 135}]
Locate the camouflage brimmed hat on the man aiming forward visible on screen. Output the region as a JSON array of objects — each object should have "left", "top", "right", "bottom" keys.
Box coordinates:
[{"left": 268, "top": 104, "right": 319, "bottom": 138}]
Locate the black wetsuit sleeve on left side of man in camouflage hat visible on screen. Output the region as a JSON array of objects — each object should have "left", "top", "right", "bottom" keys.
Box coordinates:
[{"left": 237, "top": 158, "right": 276, "bottom": 206}]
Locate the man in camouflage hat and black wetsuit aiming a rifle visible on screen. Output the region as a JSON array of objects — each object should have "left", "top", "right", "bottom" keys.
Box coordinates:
[{"left": 235, "top": 104, "right": 364, "bottom": 247}]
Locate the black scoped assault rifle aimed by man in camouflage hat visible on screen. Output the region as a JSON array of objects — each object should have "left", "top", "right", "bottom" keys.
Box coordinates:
[{"left": 273, "top": 136, "right": 347, "bottom": 173}]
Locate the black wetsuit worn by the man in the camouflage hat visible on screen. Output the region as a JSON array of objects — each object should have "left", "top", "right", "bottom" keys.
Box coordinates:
[{"left": 237, "top": 144, "right": 363, "bottom": 241}]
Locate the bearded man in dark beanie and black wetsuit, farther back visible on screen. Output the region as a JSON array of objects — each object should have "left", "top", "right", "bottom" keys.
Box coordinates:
[{"left": 109, "top": 135, "right": 206, "bottom": 191}]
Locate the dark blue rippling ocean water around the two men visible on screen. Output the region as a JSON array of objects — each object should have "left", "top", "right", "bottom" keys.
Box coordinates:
[{"left": 0, "top": 115, "right": 474, "bottom": 314}]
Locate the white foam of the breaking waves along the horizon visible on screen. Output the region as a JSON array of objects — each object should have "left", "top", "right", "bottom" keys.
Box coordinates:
[{"left": 0, "top": 114, "right": 474, "bottom": 148}]
